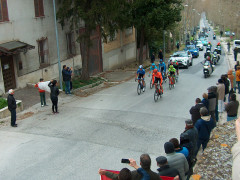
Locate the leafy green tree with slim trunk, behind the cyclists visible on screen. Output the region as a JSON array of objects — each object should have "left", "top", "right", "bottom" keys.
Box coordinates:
[{"left": 131, "top": 0, "right": 182, "bottom": 64}]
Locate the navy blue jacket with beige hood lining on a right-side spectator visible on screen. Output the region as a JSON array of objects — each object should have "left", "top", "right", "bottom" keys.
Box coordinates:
[{"left": 195, "top": 116, "right": 214, "bottom": 140}]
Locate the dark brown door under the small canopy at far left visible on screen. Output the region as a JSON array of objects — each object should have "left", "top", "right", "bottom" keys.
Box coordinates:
[{"left": 1, "top": 56, "right": 16, "bottom": 91}]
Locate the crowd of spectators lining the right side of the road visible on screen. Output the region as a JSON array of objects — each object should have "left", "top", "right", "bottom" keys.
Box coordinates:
[{"left": 99, "top": 67, "right": 240, "bottom": 180}]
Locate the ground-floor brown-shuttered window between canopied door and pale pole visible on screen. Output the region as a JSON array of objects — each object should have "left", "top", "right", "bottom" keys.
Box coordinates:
[{"left": 37, "top": 38, "right": 49, "bottom": 66}]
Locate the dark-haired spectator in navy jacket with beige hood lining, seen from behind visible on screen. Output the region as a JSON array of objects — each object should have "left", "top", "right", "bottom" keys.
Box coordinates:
[{"left": 195, "top": 107, "right": 214, "bottom": 151}]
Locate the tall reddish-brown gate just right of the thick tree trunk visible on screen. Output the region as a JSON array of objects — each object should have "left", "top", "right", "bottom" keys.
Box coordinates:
[{"left": 79, "top": 27, "right": 103, "bottom": 75}]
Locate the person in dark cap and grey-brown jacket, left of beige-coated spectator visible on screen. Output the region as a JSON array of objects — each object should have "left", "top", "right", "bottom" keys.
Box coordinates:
[{"left": 208, "top": 86, "right": 217, "bottom": 122}]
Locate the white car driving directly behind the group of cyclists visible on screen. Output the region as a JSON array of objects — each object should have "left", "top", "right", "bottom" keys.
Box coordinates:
[{"left": 168, "top": 51, "right": 193, "bottom": 69}]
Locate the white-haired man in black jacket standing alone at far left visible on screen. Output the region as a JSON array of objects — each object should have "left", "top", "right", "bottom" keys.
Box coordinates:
[{"left": 7, "top": 89, "right": 17, "bottom": 127}]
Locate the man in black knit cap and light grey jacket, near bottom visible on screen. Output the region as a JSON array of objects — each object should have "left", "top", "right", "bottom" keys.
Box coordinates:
[{"left": 164, "top": 142, "right": 189, "bottom": 180}]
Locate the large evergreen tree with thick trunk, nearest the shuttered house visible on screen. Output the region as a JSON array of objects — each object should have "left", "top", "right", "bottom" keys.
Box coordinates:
[{"left": 57, "top": 0, "right": 130, "bottom": 80}]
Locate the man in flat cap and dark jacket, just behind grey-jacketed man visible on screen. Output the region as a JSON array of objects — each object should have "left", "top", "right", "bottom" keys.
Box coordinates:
[{"left": 180, "top": 133, "right": 196, "bottom": 179}]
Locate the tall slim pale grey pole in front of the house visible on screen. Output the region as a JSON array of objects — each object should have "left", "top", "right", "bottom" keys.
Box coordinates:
[{"left": 53, "top": 0, "right": 63, "bottom": 89}]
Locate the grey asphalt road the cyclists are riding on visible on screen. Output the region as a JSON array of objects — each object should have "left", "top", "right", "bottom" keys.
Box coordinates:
[{"left": 0, "top": 19, "right": 228, "bottom": 180}]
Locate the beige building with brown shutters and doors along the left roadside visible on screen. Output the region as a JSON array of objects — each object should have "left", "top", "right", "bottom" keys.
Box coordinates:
[{"left": 0, "top": 0, "right": 136, "bottom": 94}]
